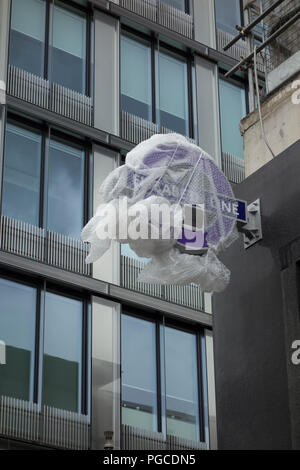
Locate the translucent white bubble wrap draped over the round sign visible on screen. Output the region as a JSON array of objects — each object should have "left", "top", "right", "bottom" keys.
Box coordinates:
[{"left": 82, "top": 134, "right": 237, "bottom": 292}]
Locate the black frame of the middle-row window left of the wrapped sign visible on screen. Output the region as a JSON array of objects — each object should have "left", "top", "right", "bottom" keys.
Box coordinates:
[{"left": 0, "top": 112, "right": 93, "bottom": 239}]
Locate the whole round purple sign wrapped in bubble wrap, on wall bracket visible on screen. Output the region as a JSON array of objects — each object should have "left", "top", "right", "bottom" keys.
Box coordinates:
[{"left": 82, "top": 134, "right": 241, "bottom": 292}]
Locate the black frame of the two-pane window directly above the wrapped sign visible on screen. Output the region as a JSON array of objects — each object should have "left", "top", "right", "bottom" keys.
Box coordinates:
[{"left": 120, "top": 24, "right": 197, "bottom": 139}]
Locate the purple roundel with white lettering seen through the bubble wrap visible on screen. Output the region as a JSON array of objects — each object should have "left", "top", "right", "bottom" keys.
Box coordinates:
[{"left": 127, "top": 140, "right": 240, "bottom": 252}]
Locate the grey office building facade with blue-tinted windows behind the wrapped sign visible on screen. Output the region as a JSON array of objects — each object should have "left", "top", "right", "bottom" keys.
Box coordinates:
[{"left": 0, "top": 0, "right": 248, "bottom": 449}]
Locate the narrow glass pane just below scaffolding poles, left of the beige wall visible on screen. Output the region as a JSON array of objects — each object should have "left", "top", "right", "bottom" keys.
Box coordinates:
[{"left": 220, "top": 80, "right": 246, "bottom": 159}]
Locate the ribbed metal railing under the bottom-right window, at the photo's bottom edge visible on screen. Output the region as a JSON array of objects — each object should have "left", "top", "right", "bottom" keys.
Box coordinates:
[{"left": 122, "top": 424, "right": 207, "bottom": 450}]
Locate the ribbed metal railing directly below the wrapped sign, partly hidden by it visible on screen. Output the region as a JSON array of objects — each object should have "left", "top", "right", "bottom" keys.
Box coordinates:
[{"left": 121, "top": 256, "right": 205, "bottom": 310}]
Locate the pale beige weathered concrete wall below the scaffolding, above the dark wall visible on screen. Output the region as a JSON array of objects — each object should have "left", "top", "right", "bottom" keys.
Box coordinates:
[{"left": 241, "top": 75, "right": 300, "bottom": 176}]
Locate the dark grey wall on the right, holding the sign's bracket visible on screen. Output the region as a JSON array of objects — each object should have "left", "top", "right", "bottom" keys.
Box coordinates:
[{"left": 213, "top": 141, "right": 300, "bottom": 449}]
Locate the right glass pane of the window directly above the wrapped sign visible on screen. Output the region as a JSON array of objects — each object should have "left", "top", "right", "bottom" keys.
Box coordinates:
[{"left": 159, "top": 53, "right": 189, "bottom": 136}]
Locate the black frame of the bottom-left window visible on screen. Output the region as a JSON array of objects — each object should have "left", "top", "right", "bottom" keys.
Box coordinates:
[{"left": 0, "top": 269, "right": 92, "bottom": 416}]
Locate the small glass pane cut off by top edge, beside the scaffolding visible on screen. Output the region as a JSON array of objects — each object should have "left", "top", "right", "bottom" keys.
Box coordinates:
[{"left": 215, "top": 0, "right": 241, "bottom": 35}]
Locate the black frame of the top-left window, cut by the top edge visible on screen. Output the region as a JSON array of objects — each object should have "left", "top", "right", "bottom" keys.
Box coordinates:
[{"left": 8, "top": 0, "right": 93, "bottom": 97}]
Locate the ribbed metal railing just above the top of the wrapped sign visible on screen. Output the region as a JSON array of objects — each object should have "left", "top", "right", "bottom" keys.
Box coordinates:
[{"left": 121, "top": 111, "right": 196, "bottom": 144}]
